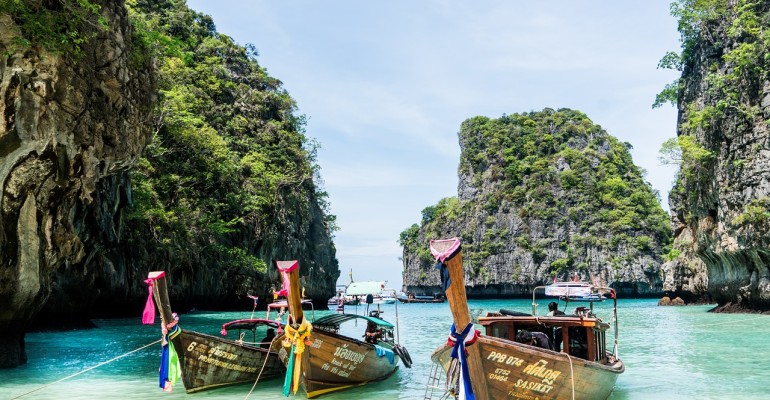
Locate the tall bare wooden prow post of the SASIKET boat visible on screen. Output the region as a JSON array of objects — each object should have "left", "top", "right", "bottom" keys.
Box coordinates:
[{"left": 444, "top": 245, "right": 491, "bottom": 400}]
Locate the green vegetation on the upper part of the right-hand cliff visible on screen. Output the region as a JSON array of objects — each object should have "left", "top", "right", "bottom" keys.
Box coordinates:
[{"left": 653, "top": 0, "right": 770, "bottom": 223}]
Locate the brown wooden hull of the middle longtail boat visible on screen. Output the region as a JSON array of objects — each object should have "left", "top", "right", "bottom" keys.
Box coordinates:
[{"left": 274, "top": 330, "right": 398, "bottom": 399}]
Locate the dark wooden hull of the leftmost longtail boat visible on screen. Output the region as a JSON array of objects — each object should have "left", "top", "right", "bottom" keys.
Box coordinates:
[{"left": 174, "top": 330, "right": 286, "bottom": 393}]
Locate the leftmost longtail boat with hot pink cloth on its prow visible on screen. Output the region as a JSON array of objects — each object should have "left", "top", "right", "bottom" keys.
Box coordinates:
[{"left": 142, "top": 272, "right": 285, "bottom": 393}]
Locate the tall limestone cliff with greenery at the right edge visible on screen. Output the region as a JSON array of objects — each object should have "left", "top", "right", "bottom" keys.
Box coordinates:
[{"left": 664, "top": 1, "right": 770, "bottom": 311}]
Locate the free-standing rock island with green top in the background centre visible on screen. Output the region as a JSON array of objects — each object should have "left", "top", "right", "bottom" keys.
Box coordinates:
[{"left": 401, "top": 109, "right": 670, "bottom": 298}]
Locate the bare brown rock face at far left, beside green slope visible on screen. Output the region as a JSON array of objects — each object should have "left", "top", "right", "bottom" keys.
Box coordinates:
[{"left": 0, "top": 1, "right": 154, "bottom": 367}]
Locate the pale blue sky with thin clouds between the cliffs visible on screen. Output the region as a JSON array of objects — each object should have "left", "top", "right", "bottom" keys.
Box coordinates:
[{"left": 188, "top": 0, "right": 681, "bottom": 289}]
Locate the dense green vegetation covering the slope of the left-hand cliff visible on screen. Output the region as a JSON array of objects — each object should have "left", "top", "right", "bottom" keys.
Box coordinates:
[{"left": 127, "top": 0, "right": 335, "bottom": 272}]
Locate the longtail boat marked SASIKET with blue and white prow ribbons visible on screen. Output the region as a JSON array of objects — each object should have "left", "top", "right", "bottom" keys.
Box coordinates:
[{"left": 430, "top": 238, "right": 625, "bottom": 400}]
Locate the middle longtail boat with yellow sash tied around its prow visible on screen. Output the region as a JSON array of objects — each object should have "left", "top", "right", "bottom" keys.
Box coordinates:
[{"left": 274, "top": 261, "right": 411, "bottom": 398}]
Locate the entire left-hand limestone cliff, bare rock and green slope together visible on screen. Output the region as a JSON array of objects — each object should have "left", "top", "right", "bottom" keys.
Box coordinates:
[{"left": 0, "top": 0, "right": 339, "bottom": 367}]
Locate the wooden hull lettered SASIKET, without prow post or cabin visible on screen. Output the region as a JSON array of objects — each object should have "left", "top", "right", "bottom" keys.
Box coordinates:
[{"left": 432, "top": 336, "right": 625, "bottom": 400}]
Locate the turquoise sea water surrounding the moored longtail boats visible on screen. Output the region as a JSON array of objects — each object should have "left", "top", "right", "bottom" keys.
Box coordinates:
[{"left": 0, "top": 300, "right": 770, "bottom": 400}]
